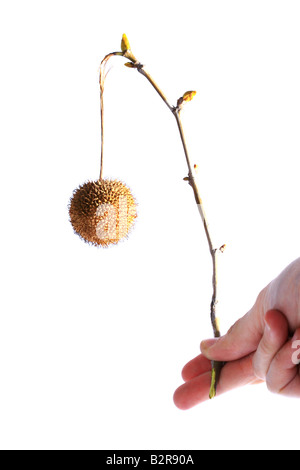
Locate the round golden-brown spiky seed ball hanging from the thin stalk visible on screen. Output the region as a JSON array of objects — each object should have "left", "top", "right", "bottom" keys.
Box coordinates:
[{"left": 69, "top": 179, "right": 137, "bottom": 247}]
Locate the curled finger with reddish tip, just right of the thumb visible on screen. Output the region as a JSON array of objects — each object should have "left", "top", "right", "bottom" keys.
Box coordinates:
[{"left": 253, "top": 310, "right": 289, "bottom": 380}]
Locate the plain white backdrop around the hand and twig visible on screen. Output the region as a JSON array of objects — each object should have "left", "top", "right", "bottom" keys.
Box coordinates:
[{"left": 0, "top": 0, "right": 300, "bottom": 450}]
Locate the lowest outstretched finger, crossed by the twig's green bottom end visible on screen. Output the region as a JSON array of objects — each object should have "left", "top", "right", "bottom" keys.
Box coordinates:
[{"left": 173, "top": 355, "right": 256, "bottom": 410}]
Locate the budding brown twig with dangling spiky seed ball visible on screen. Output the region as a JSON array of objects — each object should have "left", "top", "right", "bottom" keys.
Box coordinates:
[{"left": 69, "top": 34, "right": 225, "bottom": 398}]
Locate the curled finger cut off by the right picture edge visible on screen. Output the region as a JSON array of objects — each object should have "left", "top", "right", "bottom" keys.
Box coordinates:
[{"left": 266, "top": 328, "right": 300, "bottom": 397}]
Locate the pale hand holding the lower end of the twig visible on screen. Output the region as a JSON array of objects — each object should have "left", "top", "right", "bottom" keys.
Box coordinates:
[{"left": 174, "top": 258, "right": 300, "bottom": 410}]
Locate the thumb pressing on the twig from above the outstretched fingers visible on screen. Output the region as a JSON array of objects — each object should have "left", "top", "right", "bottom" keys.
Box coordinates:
[{"left": 200, "top": 306, "right": 264, "bottom": 362}]
